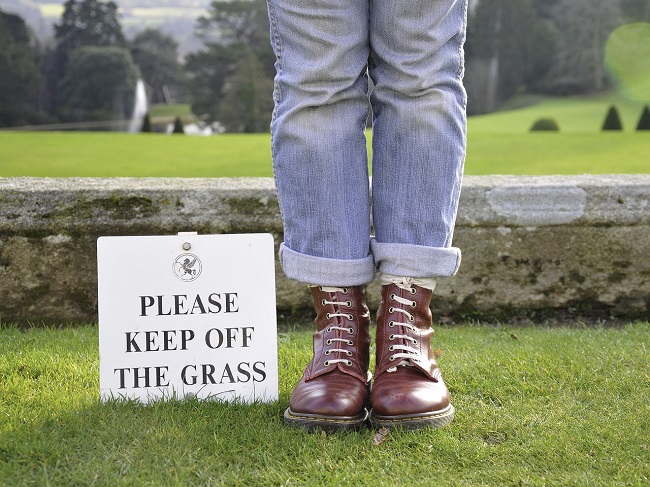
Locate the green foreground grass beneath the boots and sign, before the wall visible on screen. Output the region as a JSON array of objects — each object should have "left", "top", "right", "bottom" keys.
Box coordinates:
[{"left": 0, "top": 323, "right": 650, "bottom": 486}]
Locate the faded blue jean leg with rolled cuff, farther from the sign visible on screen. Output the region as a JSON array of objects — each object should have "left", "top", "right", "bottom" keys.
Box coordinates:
[{"left": 369, "top": 0, "right": 467, "bottom": 277}]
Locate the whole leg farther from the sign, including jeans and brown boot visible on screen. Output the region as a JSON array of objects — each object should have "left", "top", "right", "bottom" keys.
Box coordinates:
[{"left": 369, "top": 0, "right": 467, "bottom": 428}]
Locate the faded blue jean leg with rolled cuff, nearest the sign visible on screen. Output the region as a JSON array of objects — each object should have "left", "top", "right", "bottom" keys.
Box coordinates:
[{"left": 268, "top": 0, "right": 374, "bottom": 286}]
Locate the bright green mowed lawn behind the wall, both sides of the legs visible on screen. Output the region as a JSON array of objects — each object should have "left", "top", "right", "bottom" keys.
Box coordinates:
[{"left": 0, "top": 91, "right": 650, "bottom": 177}]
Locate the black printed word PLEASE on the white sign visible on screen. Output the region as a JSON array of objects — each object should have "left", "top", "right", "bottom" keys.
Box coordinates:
[{"left": 140, "top": 293, "right": 239, "bottom": 316}]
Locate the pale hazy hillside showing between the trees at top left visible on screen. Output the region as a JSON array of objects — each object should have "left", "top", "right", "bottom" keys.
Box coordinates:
[{"left": 0, "top": 0, "right": 210, "bottom": 55}]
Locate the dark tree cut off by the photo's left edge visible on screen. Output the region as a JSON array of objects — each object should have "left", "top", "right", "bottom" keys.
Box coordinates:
[{"left": 0, "top": 11, "right": 41, "bottom": 126}]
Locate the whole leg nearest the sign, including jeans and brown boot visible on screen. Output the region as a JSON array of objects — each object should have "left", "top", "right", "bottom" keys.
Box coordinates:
[{"left": 268, "top": 0, "right": 375, "bottom": 429}]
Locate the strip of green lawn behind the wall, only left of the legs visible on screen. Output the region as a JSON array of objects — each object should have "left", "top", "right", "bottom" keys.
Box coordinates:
[{"left": 0, "top": 132, "right": 272, "bottom": 177}]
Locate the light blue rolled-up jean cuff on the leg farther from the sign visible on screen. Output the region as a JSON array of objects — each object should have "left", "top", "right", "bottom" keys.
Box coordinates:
[{"left": 370, "top": 239, "right": 460, "bottom": 277}]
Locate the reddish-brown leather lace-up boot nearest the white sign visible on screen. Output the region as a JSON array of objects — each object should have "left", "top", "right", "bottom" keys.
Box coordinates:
[{"left": 284, "top": 286, "right": 370, "bottom": 430}]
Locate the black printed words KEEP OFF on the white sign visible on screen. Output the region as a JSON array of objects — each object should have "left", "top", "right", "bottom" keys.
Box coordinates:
[{"left": 124, "top": 326, "right": 255, "bottom": 353}]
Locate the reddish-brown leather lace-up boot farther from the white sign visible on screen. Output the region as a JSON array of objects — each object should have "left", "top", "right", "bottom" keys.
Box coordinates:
[{"left": 370, "top": 284, "right": 454, "bottom": 429}]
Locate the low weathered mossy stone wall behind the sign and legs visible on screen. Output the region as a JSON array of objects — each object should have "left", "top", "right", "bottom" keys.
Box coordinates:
[{"left": 0, "top": 175, "right": 650, "bottom": 323}]
